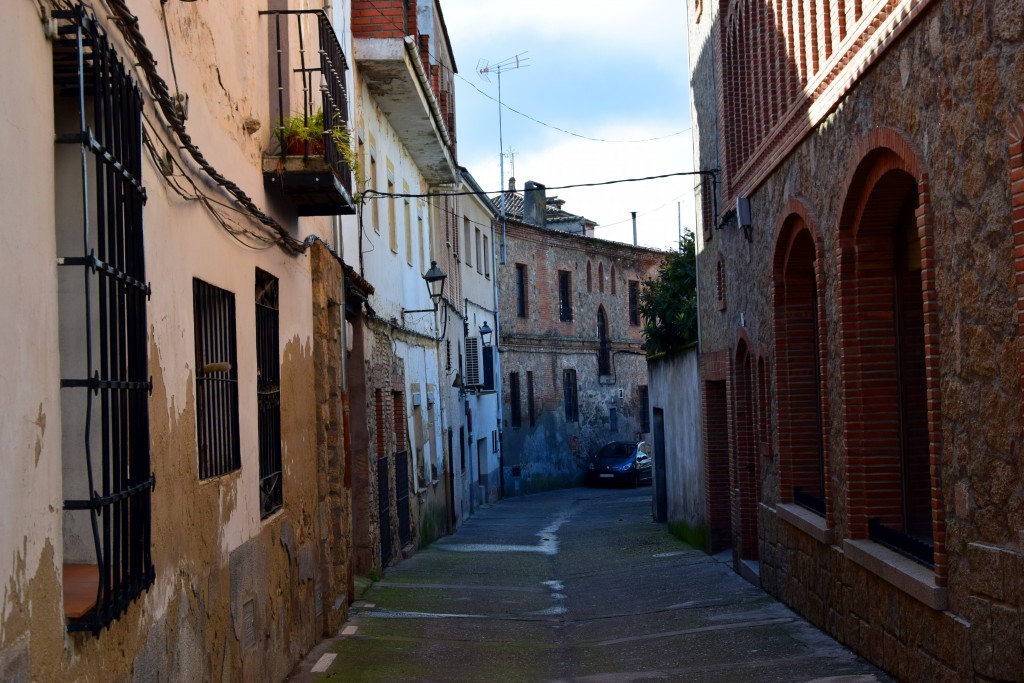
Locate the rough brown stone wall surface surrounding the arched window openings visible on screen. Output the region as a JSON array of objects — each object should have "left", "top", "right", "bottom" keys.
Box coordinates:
[{"left": 691, "top": 0, "right": 1024, "bottom": 680}]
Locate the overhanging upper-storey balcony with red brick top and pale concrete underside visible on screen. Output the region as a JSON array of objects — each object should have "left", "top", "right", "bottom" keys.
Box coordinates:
[{"left": 352, "top": 0, "right": 459, "bottom": 184}]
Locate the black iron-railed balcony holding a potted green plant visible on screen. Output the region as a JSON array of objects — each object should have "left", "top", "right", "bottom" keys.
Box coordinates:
[{"left": 260, "top": 9, "right": 355, "bottom": 216}]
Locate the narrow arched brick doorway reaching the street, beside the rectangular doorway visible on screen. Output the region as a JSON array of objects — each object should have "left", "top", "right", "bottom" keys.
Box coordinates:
[{"left": 729, "top": 328, "right": 759, "bottom": 560}]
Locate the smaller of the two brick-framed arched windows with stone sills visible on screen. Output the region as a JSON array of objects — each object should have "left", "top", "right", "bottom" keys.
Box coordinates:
[{"left": 772, "top": 200, "right": 833, "bottom": 526}]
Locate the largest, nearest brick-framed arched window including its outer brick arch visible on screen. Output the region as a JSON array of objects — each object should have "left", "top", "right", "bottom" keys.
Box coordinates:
[{"left": 838, "top": 128, "right": 947, "bottom": 586}]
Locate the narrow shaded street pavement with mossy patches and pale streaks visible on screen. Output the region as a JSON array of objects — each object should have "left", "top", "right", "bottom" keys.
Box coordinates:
[{"left": 292, "top": 487, "right": 890, "bottom": 683}]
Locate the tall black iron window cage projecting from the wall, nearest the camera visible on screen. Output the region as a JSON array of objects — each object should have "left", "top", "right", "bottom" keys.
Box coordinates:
[{"left": 53, "top": 5, "right": 156, "bottom": 634}]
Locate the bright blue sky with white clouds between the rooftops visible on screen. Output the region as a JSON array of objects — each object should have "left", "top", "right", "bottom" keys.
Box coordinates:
[{"left": 441, "top": 0, "right": 694, "bottom": 248}]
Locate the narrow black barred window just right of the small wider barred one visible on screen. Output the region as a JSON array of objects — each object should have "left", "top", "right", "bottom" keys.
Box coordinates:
[{"left": 256, "top": 268, "right": 284, "bottom": 518}]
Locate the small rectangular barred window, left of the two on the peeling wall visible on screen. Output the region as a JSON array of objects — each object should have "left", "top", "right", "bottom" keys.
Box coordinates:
[{"left": 193, "top": 278, "right": 242, "bottom": 479}]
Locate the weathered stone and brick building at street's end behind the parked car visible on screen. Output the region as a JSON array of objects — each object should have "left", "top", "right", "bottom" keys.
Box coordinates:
[{"left": 496, "top": 183, "right": 664, "bottom": 496}]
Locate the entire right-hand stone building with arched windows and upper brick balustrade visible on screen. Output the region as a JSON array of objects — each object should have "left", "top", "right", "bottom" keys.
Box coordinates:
[{"left": 689, "top": 0, "right": 1024, "bottom": 681}]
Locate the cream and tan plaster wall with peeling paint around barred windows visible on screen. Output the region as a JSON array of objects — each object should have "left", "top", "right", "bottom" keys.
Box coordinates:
[{"left": 0, "top": 0, "right": 350, "bottom": 681}]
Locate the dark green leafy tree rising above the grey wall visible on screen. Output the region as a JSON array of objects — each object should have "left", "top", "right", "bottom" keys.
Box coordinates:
[{"left": 640, "top": 232, "right": 697, "bottom": 355}]
